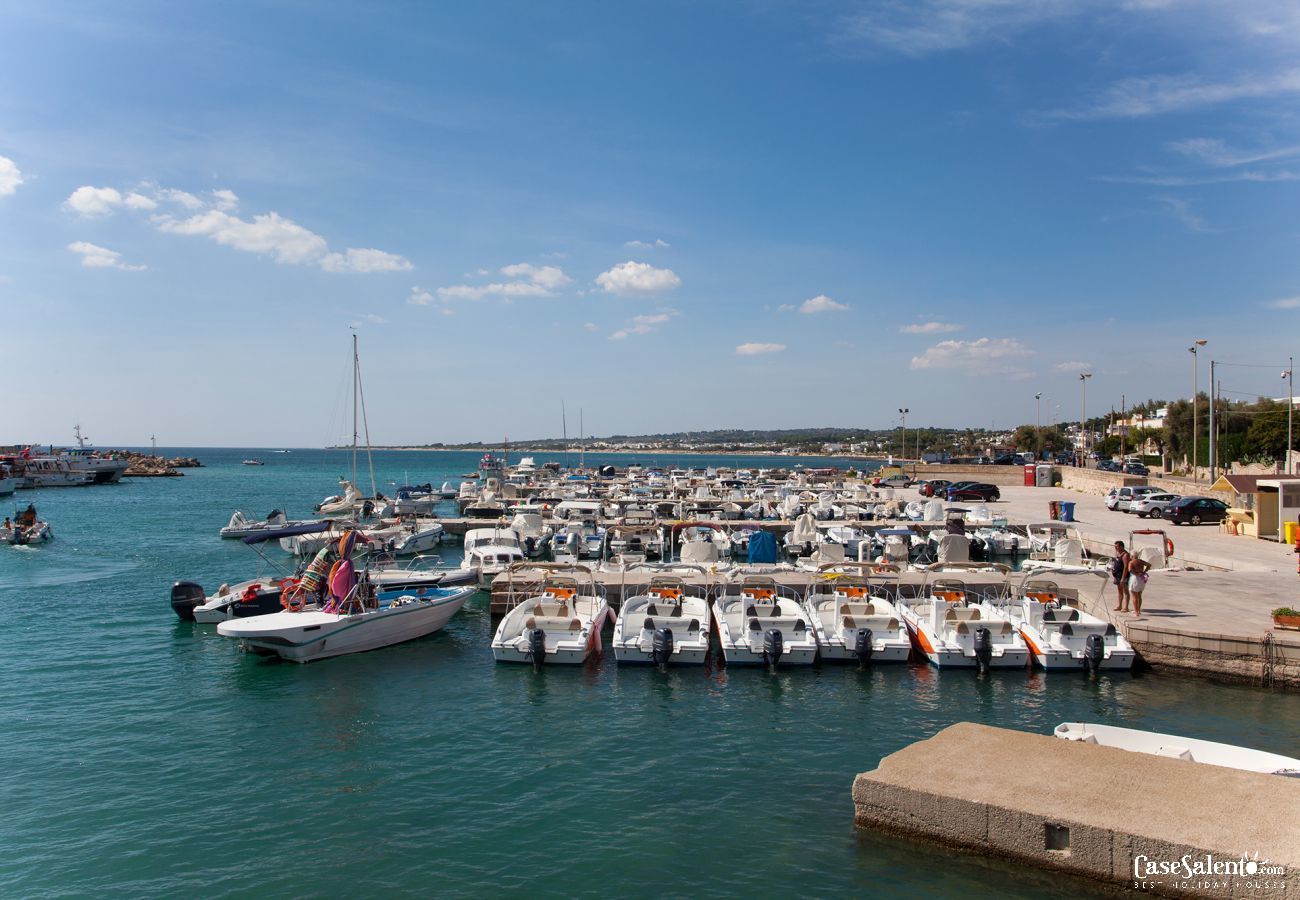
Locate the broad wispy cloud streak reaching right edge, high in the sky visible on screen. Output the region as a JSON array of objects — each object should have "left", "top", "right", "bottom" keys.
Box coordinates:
[{"left": 1049, "top": 69, "right": 1300, "bottom": 120}]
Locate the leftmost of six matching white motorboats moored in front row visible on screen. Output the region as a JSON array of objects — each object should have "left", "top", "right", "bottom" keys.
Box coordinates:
[{"left": 491, "top": 563, "right": 612, "bottom": 671}]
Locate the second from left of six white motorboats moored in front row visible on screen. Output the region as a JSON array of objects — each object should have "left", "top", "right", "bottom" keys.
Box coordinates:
[{"left": 614, "top": 570, "right": 712, "bottom": 671}]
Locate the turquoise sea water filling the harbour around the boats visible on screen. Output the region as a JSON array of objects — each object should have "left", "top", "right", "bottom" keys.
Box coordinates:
[{"left": 0, "top": 449, "right": 1300, "bottom": 897}]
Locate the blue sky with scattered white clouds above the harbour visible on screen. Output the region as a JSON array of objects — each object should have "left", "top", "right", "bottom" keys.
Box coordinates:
[{"left": 0, "top": 0, "right": 1300, "bottom": 446}]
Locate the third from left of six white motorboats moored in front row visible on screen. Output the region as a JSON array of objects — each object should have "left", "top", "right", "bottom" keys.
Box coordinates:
[{"left": 714, "top": 575, "right": 816, "bottom": 671}]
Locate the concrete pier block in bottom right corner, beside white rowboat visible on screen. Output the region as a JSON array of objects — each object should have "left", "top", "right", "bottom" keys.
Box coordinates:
[{"left": 853, "top": 722, "right": 1300, "bottom": 899}]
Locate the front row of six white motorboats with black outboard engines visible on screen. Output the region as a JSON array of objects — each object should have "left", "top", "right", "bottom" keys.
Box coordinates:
[{"left": 491, "top": 563, "right": 1135, "bottom": 672}]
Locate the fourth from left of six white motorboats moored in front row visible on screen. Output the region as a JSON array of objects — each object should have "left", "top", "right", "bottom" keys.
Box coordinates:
[{"left": 803, "top": 563, "right": 911, "bottom": 665}]
